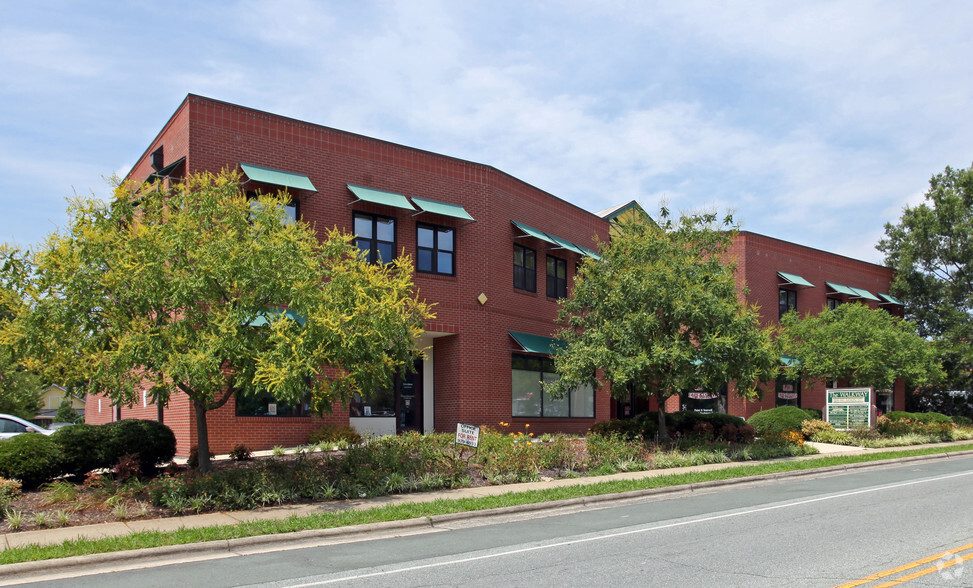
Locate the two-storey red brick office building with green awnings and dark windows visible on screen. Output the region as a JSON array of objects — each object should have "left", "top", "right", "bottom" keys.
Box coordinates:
[{"left": 85, "top": 95, "right": 903, "bottom": 456}]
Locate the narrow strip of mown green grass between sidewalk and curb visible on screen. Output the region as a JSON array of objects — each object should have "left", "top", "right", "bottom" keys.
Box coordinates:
[{"left": 0, "top": 444, "right": 973, "bottom": 565}]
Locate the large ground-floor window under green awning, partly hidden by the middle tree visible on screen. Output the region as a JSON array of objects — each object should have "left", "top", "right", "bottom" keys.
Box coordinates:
[{"left": 511, "top": 355, "right": 595, "bottom": 418}]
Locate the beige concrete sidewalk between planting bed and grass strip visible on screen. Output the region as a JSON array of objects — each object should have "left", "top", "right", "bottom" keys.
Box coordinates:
[{"left": 0, "top": 441, "right": 973, "bottom": 550}]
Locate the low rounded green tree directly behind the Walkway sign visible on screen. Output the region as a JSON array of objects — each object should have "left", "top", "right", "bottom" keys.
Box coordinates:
[{"left": 777, "top": 303, "right": 942, "bottom": 389}]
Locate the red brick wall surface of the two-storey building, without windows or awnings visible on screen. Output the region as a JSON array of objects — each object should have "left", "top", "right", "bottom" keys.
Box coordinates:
[{"left": 86, "top": 95, "right": 901, "bottom": 456}]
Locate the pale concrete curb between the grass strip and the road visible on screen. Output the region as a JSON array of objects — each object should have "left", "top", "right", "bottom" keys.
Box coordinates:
[{"left": 0, "top": 448, "right": 973, "bottom": 583}]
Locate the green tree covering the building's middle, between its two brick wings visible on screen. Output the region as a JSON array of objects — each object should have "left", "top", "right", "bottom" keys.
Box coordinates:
[{"left": 548, "top": 209, "right": 777, "bottom": 436}]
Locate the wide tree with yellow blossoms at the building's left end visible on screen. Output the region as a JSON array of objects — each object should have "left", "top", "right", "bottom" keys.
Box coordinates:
[{"left": 0, "top": 172, "right": 432, "bottom": 471}]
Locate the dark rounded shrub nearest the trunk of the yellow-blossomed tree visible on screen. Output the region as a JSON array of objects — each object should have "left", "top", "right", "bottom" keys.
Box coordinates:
[{"left": 102, "top": 419, "right": 176, "bottom": 476}]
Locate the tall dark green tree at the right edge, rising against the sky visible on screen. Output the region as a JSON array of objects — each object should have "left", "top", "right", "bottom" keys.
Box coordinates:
[{"left": 878, "top": 162, "right": 973, "bottom": 390}]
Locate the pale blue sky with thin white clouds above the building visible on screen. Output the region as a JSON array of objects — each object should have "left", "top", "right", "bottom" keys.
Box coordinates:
[{"left": 0, "top": 0, "right": 973, "bottom": 262}]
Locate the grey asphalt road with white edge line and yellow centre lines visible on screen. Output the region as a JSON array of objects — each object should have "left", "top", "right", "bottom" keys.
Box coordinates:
[{"left": 13, "top": 457, "right": 973, "bottom": 588}]
